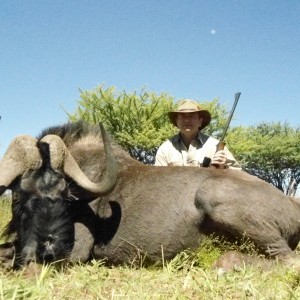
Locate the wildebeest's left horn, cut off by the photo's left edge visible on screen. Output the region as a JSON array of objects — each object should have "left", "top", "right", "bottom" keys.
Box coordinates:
[{"left": 0, "top": 135, "right": 41, "bottom": 195}]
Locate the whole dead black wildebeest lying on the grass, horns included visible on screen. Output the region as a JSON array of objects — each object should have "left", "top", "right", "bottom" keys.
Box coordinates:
[{"left": 0, "top": 122, "right": 300, "bottom": 265}]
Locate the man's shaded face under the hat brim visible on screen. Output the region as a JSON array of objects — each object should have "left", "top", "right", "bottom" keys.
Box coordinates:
[{"left": 177, "top": 112, "right": 202, "bottom": 135}]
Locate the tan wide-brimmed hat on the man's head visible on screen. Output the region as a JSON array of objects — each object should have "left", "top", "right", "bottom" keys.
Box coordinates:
[{"left": 168, "top": 99, "right": 211, "bottom": 129}]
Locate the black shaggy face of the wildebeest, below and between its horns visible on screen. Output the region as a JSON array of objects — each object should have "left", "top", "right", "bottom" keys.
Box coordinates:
[{"left": 4, "top": 143, "right": 74, "bottom": 265}]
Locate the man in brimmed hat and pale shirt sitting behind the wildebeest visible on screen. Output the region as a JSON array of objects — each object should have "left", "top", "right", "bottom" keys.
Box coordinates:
[{"left": 155, "top": 99, "right": 241, "bottom": 170}]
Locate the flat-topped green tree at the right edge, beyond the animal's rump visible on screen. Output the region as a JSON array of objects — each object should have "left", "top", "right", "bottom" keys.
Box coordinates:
[{"left": 228, "top": 122, "right": 300, "bottom": 193}]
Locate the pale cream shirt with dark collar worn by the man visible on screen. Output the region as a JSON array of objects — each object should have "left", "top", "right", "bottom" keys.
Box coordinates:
[{"left": 155, "top": 131, "right": 241, "bottom": 169}]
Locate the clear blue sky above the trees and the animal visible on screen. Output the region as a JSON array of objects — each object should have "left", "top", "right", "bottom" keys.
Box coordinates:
[{"left": 0, "top": 0, "right": 300, "bottom": 156}]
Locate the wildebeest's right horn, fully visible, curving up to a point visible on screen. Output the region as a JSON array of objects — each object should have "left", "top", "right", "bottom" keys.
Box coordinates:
[{"left": 41, "top": 124, "right": 118, "bottom": 195}]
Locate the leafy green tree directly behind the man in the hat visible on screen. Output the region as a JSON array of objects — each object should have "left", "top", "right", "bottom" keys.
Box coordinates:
[{"left": 68, "top": 85, "right": 227, "bottom": 163}]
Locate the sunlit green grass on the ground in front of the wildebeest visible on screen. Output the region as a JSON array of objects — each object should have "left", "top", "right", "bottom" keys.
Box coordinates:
[{"left": 0, "top": 196, "right": 300, "bottom": 300}]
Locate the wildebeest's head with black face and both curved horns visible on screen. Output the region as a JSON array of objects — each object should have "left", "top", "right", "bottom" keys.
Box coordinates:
[{"left": 0, "top": 123, "right": 117, "bottom": 264}]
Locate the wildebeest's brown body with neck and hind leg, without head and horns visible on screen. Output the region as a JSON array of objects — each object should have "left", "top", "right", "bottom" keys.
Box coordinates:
[{"left": 0, "top": 123, "right": 300, "bottom": 264}]
